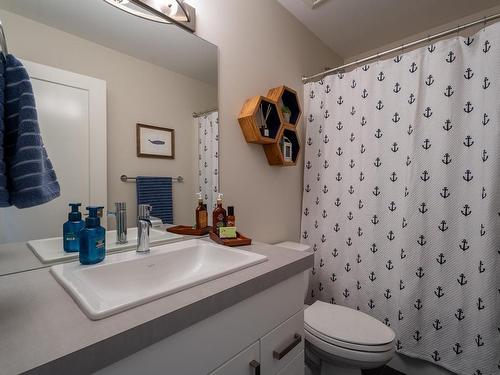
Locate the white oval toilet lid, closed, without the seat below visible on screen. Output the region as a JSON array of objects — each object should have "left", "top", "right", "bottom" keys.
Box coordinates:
[{"left": 304, "top": 301, "right": 396, "bottom": 346}]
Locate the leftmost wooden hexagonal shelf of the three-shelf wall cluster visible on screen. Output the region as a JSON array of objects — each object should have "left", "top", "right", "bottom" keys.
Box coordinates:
[{"left": 238, "top": 96, "right": 283, "bottom": 145}]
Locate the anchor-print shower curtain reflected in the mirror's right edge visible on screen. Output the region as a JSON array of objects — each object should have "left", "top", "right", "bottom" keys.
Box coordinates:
[{"left": 197, "top": 111, "right": 219, "bottom": 217}]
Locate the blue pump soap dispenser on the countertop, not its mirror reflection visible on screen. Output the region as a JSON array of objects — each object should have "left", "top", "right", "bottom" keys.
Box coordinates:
[{"left": 80, "top": 206, "right": 106, "bottom": 264}]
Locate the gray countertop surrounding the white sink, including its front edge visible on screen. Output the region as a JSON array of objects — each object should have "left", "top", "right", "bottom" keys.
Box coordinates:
[{"left": 0, "top": 243, "right": 313, "bottom": 375}]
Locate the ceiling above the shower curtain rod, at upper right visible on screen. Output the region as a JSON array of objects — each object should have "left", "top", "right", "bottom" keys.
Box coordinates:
[{"left": 278, "top": 0, "right": 500, "bottom": 59}]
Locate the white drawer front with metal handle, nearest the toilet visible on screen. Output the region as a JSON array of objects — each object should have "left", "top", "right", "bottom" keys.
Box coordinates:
[{"left": 260, "top": 310, "right": 304, "bottom": 375}]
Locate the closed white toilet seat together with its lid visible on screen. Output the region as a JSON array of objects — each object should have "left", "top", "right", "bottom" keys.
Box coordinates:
[{"left": 304, "top": 301, "right": 395, "bottom": 354}]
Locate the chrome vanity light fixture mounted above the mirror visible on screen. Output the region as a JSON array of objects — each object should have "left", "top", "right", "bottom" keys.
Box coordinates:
[{"left": 104, "top": 0, "right": 196, "bottom": 32}]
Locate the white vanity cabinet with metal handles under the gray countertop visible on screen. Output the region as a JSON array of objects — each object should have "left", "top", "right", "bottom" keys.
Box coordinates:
[{"left": 97, "top": 273, "right": 304, "bottom": 375}]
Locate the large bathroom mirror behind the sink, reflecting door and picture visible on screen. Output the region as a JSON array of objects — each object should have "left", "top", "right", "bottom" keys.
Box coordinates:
[{"left": 0, "top": 0, "right": 220, "bottom": 275}]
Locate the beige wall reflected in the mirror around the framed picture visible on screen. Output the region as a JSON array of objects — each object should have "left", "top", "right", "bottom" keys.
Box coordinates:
[{"left": 0, "top": 10, "right": 217, "bottom": 226}]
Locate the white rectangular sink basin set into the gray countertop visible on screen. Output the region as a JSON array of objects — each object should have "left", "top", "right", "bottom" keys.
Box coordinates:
[{"left": 50, "top": 239, "right": 267, "bottom": 320}]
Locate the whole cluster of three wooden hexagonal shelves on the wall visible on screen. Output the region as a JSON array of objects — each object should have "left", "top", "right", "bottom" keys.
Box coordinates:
[{"left": 238, "top": 86, "right": 302, "bottom": 166}]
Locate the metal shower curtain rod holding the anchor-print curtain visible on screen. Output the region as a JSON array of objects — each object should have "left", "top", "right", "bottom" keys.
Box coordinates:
[{"left": 302, "top": 13, "right": 500, "bottom": 83}]
